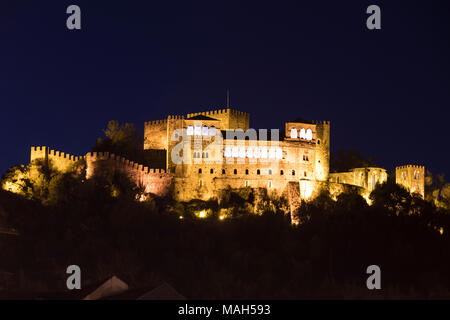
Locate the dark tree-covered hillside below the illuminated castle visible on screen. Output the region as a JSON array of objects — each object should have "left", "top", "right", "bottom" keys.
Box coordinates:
[{"left": 0, "top": 177, "right": 450, "bottom": 299}]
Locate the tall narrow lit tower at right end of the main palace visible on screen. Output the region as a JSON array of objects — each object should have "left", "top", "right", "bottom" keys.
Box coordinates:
[{"left": 314, "top": 121, "right": 330, "bottom": 181}]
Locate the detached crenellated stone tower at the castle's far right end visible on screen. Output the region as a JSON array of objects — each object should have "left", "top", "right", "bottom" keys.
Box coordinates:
[{"left": 395, "top": 165, "right": 425, "bottom": 198}]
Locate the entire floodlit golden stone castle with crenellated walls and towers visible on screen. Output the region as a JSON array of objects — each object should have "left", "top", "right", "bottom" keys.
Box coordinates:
[{"left": 26, "top": 109, "right": 424, "bottom": 205}]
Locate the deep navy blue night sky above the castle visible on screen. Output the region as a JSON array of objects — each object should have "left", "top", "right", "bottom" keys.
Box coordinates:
[{"left": 0, "top": 0, "right": 450, "bottom": 180}]
